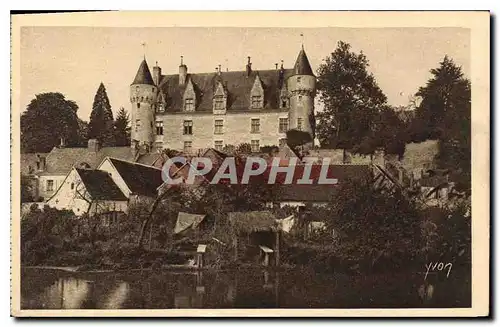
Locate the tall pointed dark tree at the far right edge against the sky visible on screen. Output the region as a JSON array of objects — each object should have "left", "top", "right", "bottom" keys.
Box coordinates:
[{"left": 410, "top": 56, "right": 471, "bottom": 191}]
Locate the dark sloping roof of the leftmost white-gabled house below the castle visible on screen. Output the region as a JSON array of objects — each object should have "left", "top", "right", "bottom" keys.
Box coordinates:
[{"left": 75, "top": 168, "right": 127, "bottom": 201}]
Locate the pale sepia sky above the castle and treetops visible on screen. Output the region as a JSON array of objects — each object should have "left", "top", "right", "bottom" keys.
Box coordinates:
[{"left": 21, "top": 27, "right": 471, "bottom": 121}]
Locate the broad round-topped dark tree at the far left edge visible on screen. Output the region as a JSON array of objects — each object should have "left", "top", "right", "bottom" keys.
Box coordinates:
[{"left": 21, "top": 92, "right": 80, "bottom": 152}]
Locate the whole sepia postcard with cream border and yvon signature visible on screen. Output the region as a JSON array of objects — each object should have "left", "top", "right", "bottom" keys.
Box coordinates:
[{"left": 11, "top": 11, "right": 490, "bottom": 317}]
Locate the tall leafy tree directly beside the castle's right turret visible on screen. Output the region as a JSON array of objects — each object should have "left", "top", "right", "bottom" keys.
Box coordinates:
[{"left": 316, "top": 41, "right": 387, "bottom": 154}]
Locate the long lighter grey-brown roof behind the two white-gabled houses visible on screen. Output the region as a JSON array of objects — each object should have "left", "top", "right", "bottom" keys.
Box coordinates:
[{"left": 42, "top": 146, "right": 134, "bottom": 175}]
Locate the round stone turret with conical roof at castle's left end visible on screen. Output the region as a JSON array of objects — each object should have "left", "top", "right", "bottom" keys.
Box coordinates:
[{"left": 130, "top": 59, "right": 157, "bottom": 149}]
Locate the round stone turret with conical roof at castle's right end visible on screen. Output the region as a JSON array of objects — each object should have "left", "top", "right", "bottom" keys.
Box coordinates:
[{"left": 287, "top": 47, "right": 316, "bottom": 138}]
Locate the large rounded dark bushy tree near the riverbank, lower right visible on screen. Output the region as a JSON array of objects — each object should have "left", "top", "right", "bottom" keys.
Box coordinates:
[{"left": 327, "top": 180, "right": 424, "bottom": 270}]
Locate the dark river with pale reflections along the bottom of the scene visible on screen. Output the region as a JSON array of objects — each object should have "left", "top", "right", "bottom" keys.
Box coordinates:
[{"left": 21, "top": 268, "right": 471, "bottom": 309}]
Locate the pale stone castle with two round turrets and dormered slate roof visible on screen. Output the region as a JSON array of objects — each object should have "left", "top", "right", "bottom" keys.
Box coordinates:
[{"left": 130, "top": 47, "right": 316, "bottom": 153}]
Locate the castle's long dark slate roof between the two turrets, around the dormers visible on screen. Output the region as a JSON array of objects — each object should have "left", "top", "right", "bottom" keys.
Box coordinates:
[{"left": 159, "top": 69, "right": 293, "bottom": 112}]
